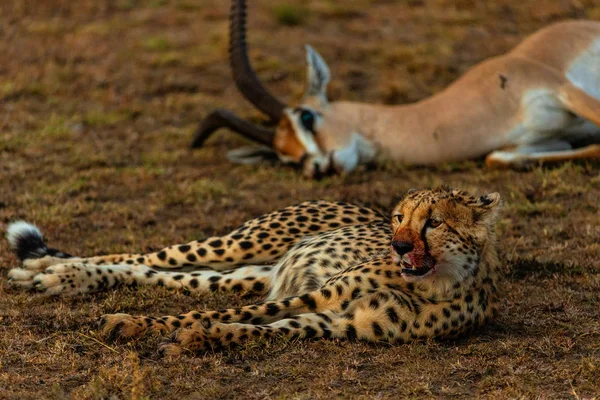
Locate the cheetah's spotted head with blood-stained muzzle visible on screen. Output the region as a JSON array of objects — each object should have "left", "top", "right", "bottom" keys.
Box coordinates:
[{"left": 391, "top": 188, "right": 500, "bottom": 284}]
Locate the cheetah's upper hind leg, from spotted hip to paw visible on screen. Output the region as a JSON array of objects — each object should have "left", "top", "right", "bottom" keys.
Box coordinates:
[{"left": 18, "top": 201, "right": 382, "bottom": 271}]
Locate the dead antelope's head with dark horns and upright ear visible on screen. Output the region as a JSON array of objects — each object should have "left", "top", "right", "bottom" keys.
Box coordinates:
[{"left": 192, "top": 0, "right": 374, "bottom": 177}]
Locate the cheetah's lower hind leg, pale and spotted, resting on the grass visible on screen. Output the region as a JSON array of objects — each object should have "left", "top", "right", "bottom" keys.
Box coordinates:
[{"left": 9, "top": 262, "right": 272, "bottom": 296}]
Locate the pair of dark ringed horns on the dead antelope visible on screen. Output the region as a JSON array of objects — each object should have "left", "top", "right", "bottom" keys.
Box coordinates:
[{"left": 192, "top": 0, "right": 286, "bottom": 148}]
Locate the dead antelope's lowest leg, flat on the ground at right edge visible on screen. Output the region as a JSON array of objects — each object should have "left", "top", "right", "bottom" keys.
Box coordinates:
[{"left": 485, "top": 144, "right": 600, "bottom": 168}]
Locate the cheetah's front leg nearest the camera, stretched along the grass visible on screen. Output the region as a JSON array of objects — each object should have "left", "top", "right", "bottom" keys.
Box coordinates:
[{"left": 159, "top": 291, "right": 422, "bottom": 356}]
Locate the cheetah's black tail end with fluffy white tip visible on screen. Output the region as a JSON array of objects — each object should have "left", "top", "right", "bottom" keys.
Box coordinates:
[{"left": 6, "top": 221, "right": 73, "bottom": 261}]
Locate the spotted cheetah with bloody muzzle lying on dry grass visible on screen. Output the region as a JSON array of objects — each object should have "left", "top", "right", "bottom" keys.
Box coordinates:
[{"left": 7, "top": 187, "right": 500, "bottom": 356}]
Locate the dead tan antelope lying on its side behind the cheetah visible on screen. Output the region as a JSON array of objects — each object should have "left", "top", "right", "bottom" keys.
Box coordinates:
[{"left": 194, "top": 1, "right": 600, "bottom": 177}]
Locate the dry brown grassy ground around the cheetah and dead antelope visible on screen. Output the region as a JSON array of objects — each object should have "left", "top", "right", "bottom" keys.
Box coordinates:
[{"left": 0, "top": 0, "right": 600, "bottom": 399}]
